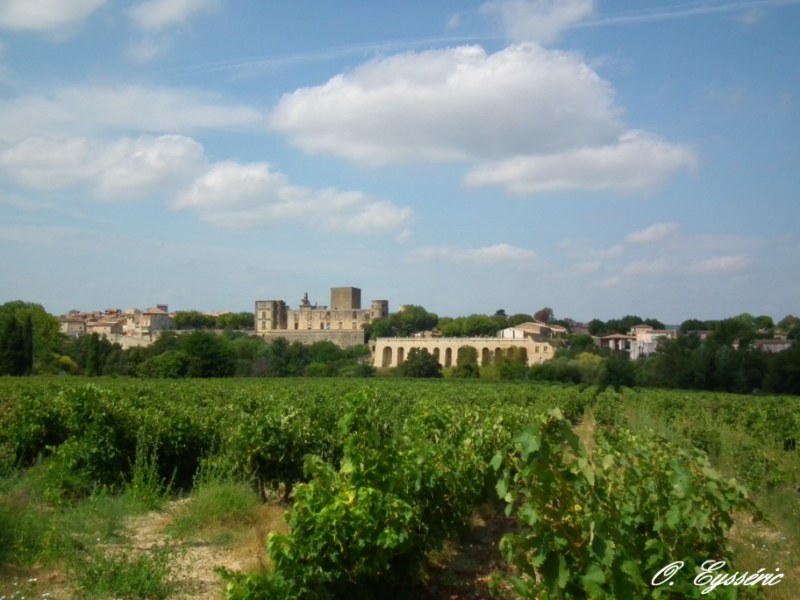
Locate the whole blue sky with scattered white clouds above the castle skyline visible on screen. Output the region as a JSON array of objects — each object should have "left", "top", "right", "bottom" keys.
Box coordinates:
[{"left": 0, "top": 0, "right": 800, "bottom": 323}]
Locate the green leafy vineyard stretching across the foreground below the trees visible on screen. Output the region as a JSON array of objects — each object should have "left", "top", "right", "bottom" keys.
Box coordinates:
[{"left": 0, "top": 378, "right": 800, "bottom": 600}]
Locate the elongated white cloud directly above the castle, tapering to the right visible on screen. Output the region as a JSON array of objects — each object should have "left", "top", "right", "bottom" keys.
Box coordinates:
[{"left": 173, "top": 161, "right": 412, "bottom": 234}]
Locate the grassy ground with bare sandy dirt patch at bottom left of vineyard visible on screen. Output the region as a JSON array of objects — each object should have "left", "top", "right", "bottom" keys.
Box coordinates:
[{"left": 0, "top": 447, "right": 287, "bottom": 600}]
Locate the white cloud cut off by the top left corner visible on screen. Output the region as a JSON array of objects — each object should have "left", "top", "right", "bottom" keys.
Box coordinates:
[{"left": 0, "top": 0, "right": 106, "bottom": 32}]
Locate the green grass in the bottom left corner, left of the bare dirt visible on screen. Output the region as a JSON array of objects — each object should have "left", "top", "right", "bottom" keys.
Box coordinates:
[{"left": 0, "top": 450, "right": 175, "bottom": 598}]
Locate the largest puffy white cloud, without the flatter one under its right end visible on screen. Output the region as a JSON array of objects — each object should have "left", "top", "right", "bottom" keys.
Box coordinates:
[{"left": 269, "top": 44, "right": 622, "bottom": 166}]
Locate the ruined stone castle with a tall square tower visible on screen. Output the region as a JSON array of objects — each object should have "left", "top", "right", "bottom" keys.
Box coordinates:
[{"left": 255, "top": 287, "right": 389, "bottom": 348}]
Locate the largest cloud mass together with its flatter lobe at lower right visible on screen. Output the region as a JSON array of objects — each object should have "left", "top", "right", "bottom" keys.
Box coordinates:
[{"left": 268, "top": 44, "right": 695, "bottom": 195}]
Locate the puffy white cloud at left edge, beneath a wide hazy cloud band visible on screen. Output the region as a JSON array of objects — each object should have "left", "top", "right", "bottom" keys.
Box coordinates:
[{"left": 0, "top": 135, "right": 205, "bottom": 198}]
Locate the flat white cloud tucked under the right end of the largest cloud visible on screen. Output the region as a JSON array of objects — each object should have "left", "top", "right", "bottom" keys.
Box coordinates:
[{"left": 465, "top": 132, "right": 695, "bottom": 195}]
